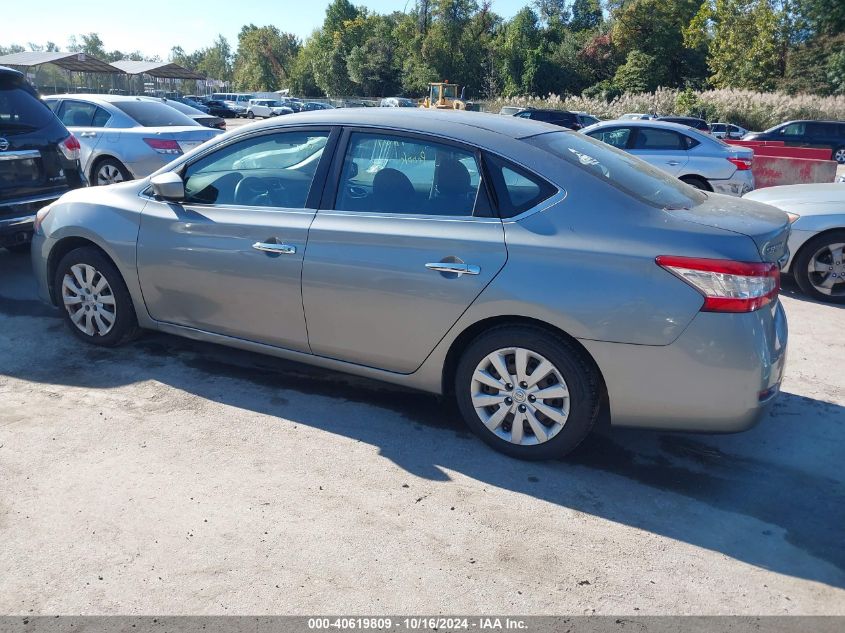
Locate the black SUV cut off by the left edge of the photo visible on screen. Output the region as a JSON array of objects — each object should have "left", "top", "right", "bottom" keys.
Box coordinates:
[{"left": 0, "top": 66, "right": 87, "bottom": 250}]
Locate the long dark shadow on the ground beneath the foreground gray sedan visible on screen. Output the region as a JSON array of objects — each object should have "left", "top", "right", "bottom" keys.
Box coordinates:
[{"left": 0, "top": 247, "right": 845, "bottom": 587}]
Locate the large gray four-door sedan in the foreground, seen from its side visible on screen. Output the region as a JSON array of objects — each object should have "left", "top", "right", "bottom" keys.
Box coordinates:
[{"left": 32, "top": 108, "right": 789, "bottom": 459}]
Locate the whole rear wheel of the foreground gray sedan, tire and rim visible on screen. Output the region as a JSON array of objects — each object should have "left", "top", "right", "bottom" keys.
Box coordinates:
[{"left": 454, "top": 326, "right": 599, "bottom": 460}]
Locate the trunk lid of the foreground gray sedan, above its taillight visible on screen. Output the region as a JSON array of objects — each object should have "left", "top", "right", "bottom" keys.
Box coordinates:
[{"left": 666, "top": 193, "right": 789, "bottom": 262}]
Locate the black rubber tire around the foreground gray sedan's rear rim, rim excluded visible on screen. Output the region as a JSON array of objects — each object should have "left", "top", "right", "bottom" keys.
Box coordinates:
[{"left": 454, "top": 325, "right": 600, "bottom": 460}]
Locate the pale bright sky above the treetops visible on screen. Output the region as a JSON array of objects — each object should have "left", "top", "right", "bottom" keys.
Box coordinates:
[{"left": 6, "top": 0, "right": 530, "bottom": 59}]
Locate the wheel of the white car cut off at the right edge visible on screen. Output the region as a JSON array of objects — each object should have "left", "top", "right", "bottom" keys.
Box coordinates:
[{"left": 792, "top": 230, "right": 845, "bottom": 303}]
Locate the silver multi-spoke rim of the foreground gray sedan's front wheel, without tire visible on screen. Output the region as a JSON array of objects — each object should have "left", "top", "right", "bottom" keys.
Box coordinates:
[{"left": 62, "top": 264, "right": 117, "bottom": 336}]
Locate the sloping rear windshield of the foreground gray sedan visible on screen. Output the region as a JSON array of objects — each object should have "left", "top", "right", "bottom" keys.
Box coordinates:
[{"left": 523, "top": 132, "right": 707, "bottom": 209}]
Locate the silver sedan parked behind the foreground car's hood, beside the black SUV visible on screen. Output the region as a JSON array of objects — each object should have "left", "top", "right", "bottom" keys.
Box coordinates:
[{"left": 44, "top": 94, "right": 223, "bottom": 185}]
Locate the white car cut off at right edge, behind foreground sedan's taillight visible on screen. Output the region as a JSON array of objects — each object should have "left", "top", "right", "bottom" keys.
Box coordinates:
[{"left": 744, "top": 183, "right": 845, "bottom": 303}]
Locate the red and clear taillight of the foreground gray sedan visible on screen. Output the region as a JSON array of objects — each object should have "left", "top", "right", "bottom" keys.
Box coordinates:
[{"left": 656, "top": 255, "right": 780, "bottom": 312}]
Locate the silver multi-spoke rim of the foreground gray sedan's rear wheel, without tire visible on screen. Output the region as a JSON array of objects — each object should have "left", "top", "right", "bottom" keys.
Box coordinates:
[{"left": 470, "top": 347, "right": 570, "bottom": 446}]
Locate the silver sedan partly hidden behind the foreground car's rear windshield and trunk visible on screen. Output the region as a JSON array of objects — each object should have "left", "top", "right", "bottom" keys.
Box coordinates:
[{"left": 581, "top": 120, "right": 754, "bottom": 196}]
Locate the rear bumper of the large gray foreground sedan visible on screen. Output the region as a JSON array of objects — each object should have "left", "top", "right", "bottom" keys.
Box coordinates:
[{"left": 582, "top": 302, "right": 788, "bottom": 433}]
